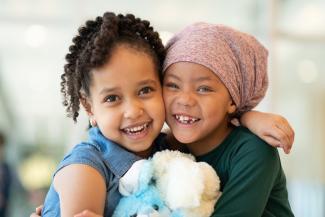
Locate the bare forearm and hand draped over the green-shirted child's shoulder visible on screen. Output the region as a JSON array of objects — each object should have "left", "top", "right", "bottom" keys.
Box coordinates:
[{"left": 240, "top": 111, "right": 294, "bottom": 154}]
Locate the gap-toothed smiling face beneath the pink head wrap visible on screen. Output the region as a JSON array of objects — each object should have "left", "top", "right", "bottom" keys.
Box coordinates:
[{"left": 163, "top": 62, "right": 236, "bottom": 155}]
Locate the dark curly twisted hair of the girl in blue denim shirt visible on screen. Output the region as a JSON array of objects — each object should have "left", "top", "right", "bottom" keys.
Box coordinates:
[{"left": 61, "top": 12, "right": 165, "bottom": 122}]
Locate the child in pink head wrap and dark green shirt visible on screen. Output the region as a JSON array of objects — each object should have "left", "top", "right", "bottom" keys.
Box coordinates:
[{"left": 163, "top": 23, "right": 293, "bottom": 217}]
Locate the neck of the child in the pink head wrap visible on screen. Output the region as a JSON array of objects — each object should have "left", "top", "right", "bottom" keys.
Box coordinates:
[{"left": 186, "top": 124, "right": 234, "bottom": 156}]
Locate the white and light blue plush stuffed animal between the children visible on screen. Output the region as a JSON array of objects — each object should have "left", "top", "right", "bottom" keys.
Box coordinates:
[{"left": 113, "top": 150, "right": 221, "bottom": 217}]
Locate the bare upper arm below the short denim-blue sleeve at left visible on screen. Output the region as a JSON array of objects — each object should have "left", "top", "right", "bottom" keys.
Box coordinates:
[{"left": 54, "top": 164, "right": 106, "bottom": 217}]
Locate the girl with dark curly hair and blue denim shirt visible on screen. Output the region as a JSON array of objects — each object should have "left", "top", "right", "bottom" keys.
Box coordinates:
[{"left": 38, "top": 12, "right": 292, "bottom": 217}]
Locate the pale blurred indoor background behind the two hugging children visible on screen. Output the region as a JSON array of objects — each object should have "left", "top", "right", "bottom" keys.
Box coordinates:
[{"left": 0, "top": 0, "right": 325, "bottom": 217}]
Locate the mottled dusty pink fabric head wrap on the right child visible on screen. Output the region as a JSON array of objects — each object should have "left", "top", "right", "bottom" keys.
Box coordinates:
[{"left": 163, "top": 23, "right": 268, "bottom": 114}]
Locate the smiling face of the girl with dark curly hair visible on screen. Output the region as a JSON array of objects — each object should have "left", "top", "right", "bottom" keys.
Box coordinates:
[{"left": 85, "top": 44, "right": 165, "bottom": 157}]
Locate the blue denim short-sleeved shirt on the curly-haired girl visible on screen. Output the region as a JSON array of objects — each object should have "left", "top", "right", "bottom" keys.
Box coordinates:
[{"left": 42, "top": 127, "right": 166, "bottom": 217}]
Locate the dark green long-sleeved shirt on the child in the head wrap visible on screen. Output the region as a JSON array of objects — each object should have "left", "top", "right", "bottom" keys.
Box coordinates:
[{"left": 197, "top": 127, "right": 294, "bottom": 217}]
